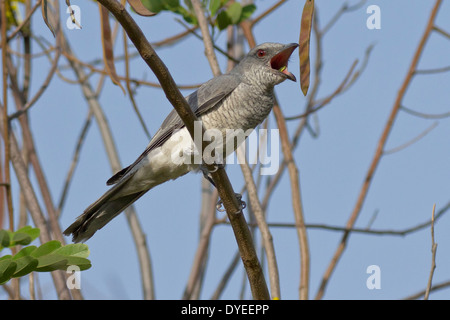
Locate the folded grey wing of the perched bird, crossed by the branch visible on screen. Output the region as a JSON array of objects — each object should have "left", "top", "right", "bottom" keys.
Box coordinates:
[{"left": 106, "top": 74, "right": 241, "bottom": 185}]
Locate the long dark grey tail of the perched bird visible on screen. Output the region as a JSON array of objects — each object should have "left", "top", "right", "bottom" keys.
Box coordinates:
[{"left": 63, "top": 178, "right": 148, "bottom": 242}]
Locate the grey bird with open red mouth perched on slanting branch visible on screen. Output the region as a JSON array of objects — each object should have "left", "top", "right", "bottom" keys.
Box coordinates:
[{"left": 64, "top": 43, "right": 298, "bottom": 242}]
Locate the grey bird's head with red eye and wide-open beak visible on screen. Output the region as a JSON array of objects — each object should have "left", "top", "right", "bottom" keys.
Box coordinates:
[{"left": 237, "top": 42, "right": 298, "bottom": 86}]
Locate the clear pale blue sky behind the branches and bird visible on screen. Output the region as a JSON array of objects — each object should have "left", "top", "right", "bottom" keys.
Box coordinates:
[{"left": 3, "top": 0, "right": 450, "bottom": 299}]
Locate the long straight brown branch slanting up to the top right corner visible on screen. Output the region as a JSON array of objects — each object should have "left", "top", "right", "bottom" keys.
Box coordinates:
[{"left": 316, "top": 0, "right": 442, "bottom": 299}]
